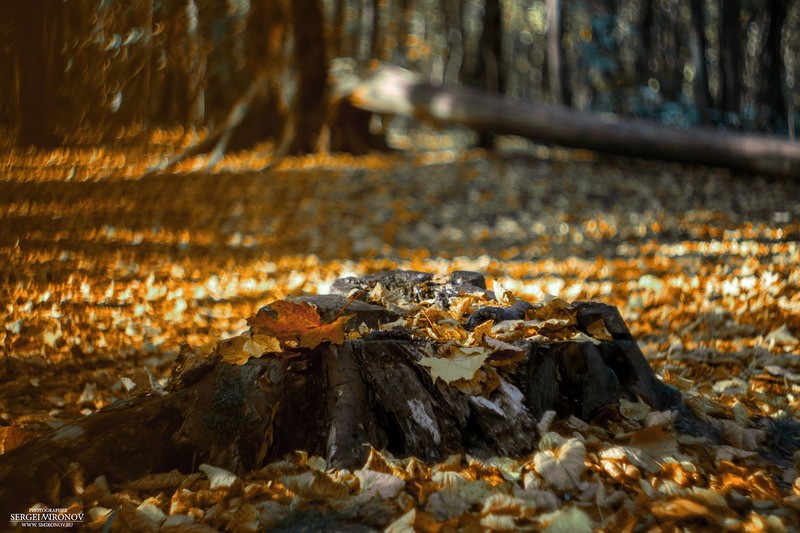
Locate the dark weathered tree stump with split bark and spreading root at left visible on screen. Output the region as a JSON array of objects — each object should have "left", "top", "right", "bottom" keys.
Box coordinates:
[{"left": 0, "top": 271, "right": 718, "bottom": 512}]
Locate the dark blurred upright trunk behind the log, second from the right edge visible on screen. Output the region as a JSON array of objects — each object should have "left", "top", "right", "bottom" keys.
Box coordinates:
[{"left": 719, "top": 0, "right": 742, "bottom": 121}]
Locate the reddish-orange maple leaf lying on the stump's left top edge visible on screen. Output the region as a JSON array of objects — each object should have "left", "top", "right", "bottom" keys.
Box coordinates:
[{"left": 247, "top": 300, "right": 350, "bottom": 348}]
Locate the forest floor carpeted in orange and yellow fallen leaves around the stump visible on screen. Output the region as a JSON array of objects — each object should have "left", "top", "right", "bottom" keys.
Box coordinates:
[{"left": 0, "top": 142, "right": 800, "bottom": 531}]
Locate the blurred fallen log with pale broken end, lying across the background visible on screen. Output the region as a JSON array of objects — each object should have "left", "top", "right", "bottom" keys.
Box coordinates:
[{"left": 352, "top": 66, "right": 800, "bottom": 176}]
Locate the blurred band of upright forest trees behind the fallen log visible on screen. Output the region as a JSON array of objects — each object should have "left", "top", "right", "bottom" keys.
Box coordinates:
[{"left": 0, "top": 0, "right": 800, "bottom": 153}]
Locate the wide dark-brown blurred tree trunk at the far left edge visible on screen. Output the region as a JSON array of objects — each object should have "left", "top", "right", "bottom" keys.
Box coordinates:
[{"left": 11, "top": 0, "right": 67, "bottom": 148}]
